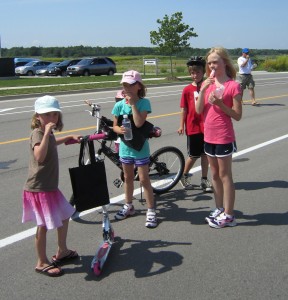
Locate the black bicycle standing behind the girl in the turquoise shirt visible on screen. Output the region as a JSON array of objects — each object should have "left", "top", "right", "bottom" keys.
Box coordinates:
[{"left": 67, "top": 101, "right": 185, "bottom": 194}]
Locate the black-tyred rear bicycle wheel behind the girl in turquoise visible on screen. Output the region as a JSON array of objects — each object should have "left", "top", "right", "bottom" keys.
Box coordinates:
[{"left": 149, "top": 146, "right": 185, "bottom": 194}]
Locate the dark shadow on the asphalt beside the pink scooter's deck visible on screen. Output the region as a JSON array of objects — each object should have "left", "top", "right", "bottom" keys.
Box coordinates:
[{"left": 63, "top": 237, "right": 191, "bottom": 281}]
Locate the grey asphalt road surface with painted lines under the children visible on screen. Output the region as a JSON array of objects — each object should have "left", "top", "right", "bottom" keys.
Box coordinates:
[{"left": 0, "top": 72, "right": 288, "bottom": 300}]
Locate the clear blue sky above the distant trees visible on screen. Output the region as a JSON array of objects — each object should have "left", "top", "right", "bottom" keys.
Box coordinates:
[{"left": 0, "top": 0, "right": 288, "bottom": 49}]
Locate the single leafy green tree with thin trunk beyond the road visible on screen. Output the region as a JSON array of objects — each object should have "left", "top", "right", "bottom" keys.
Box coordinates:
[{"left": 150, "top": 12, "right": 198, "bottom": 77}]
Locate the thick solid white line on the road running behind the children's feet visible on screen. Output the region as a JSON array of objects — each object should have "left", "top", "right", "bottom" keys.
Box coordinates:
[{"left": 0, "top": 134, "right": 288, "bottom": 248}]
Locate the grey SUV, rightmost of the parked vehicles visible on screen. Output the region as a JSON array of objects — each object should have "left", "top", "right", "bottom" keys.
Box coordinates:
[{"left": 67, "top": 57, "right": 116, "bottom": 76}]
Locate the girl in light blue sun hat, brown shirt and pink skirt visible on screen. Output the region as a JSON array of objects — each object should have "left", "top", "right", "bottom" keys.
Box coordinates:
[{"left": 22, "top": 95, "right": 81, "bottom": 277}]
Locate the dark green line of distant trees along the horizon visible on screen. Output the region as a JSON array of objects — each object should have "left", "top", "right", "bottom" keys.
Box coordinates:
[{"left": 1, "top": 45, "right": 288, "bottom": 58}]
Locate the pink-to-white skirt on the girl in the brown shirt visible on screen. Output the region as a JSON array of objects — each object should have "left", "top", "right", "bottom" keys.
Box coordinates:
[{"left": 22, "top": 190, "right": 75, "bottom": 229}]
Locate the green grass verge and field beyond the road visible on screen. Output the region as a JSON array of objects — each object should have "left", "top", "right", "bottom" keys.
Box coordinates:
[{"left": 0, "top": 56, "right": 282, "bottom": 97}]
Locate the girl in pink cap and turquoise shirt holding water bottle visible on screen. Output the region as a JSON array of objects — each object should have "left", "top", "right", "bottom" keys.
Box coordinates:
[{"left": 112, "top": 70, "right": 158, "bottom": 228}]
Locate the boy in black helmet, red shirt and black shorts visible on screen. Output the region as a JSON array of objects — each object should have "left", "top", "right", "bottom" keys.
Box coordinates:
[{"left": 177, "top": 57, "right": 213, "bottom": 192}]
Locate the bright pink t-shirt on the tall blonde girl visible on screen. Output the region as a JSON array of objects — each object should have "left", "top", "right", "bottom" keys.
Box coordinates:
[{"left": 204, "top": 79, "right": 241, "bottom": 144}]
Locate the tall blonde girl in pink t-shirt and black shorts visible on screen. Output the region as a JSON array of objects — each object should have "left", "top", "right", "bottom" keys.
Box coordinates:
[{"left": 196, "top": 47, "right": 242, "bottom": 228}]
